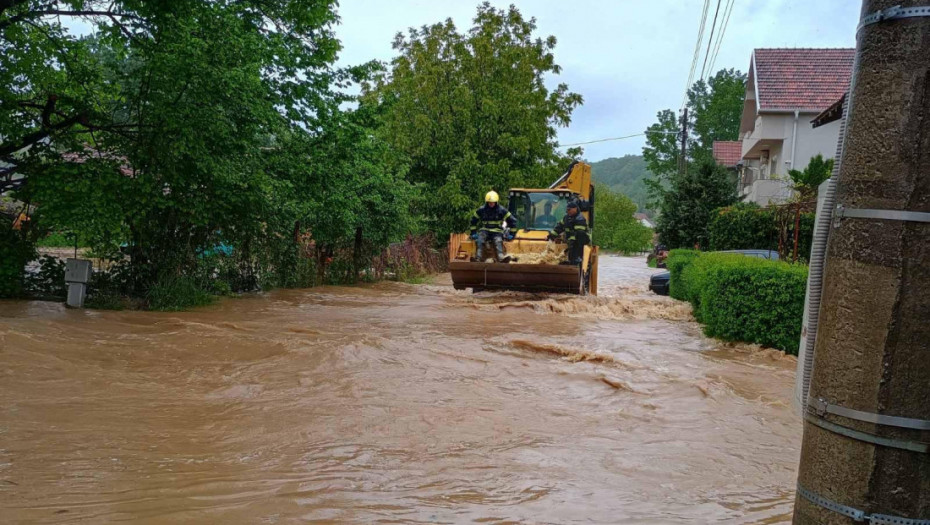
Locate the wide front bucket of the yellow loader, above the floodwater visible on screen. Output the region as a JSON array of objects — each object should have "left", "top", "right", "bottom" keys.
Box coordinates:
[{"left": 449, "top": 261, "right": 584, "bottom": 294}]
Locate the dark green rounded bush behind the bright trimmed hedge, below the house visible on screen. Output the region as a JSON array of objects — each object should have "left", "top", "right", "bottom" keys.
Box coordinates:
[{"left": 709, "top": 203, "right": 778, "bottom": 250}]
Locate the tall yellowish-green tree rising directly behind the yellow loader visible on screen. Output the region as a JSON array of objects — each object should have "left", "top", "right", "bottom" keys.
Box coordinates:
[{"left": 365, "top": 3, "right": 582, "bottom": 236}]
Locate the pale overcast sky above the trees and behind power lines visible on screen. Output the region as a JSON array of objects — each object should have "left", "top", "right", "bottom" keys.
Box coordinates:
[{"left": 336, "top": 0, "right": 861, "bottom": 161}]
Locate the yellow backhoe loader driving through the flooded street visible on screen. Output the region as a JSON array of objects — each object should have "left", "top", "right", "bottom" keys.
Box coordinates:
[{"left": 449, "top": 162, "right": 597, "bottom": 295}]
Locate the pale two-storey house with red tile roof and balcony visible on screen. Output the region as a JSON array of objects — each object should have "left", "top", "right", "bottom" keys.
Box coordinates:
[{"left": 738, "top": 48, "right": 855, "bottom": 206}]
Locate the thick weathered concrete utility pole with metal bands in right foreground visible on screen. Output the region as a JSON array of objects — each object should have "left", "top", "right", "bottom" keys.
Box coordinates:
[{"left": 794, "top": 0, "right": 930, "bottom": 525}]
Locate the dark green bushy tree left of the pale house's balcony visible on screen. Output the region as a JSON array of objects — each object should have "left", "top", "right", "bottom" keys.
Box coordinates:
[{"left": 656, "top": 161, "right": 736, "bottom": 248}]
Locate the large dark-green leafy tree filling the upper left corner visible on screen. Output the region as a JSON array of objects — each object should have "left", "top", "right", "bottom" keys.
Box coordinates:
[{"left": 0, "top": 0, "right": 343, "bottom": 270}]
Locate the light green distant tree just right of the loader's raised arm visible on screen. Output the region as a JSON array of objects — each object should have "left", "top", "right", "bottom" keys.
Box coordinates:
[{"left": 594, "top": 186, "right": 652, "bottom": 253}]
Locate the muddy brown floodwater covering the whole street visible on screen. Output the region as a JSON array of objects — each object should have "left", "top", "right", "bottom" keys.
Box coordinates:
[{"left": 0, "top": 257, "right": 801, "bottom": 524}]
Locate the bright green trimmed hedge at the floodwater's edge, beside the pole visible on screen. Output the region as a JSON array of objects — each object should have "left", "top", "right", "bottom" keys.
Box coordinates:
[{"left": 669, "top": 250, "right": 807, "bottom": 354}]
